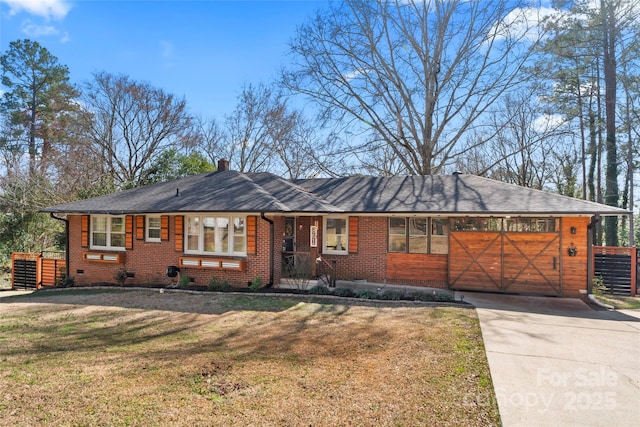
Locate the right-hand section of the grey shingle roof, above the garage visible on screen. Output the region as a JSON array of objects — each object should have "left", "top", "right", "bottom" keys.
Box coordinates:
[{"left": 298, "top": 174, "right": 628, "bottom": 215}]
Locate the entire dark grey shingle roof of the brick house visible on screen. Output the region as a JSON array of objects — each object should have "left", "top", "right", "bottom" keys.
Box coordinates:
[{"left": 43, "top": 170, "right": 628, "bottom": 215}]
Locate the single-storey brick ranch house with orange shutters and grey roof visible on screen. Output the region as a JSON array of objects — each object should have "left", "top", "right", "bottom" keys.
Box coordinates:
[{"left": 43, "top": 160, "right": 628, "bottom": 297}]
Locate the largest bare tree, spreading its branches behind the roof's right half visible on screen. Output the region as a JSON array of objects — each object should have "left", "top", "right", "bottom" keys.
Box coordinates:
[{"left": 281, "top": 0, "right": 539, "bottom": 174}]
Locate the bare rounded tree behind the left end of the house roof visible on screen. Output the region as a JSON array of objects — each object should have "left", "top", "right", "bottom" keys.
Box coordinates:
[{"left": 84, "top": 72, "right": 195, "bottom": 188}]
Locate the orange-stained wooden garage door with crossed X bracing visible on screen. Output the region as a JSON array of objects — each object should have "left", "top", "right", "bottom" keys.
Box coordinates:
[{"left": 449, "top": 232, "right": 561, "bottom": 295}]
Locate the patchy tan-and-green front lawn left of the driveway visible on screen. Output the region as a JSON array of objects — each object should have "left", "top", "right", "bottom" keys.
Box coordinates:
[{"left": 0, "top": 290, "right": 500, "bottom": 426}]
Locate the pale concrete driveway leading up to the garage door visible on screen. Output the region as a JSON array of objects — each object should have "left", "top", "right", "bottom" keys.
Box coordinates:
[{"left": 456, "top": 292, "right": 640, "bottom": 427}]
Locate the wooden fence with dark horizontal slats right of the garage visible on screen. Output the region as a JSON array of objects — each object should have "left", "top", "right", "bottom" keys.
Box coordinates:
[{"left": 593, "top": 246, "right": 638, "bottom": 296}]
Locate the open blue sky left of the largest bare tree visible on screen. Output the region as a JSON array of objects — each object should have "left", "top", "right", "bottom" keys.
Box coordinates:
[{"left": 0, "top": 0, "right": 326, "bottom": 119}]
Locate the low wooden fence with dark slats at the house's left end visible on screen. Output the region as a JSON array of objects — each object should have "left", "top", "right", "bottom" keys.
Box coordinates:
[{"left": 11, "top": 252, "right": 66, "bottom": 289}]
